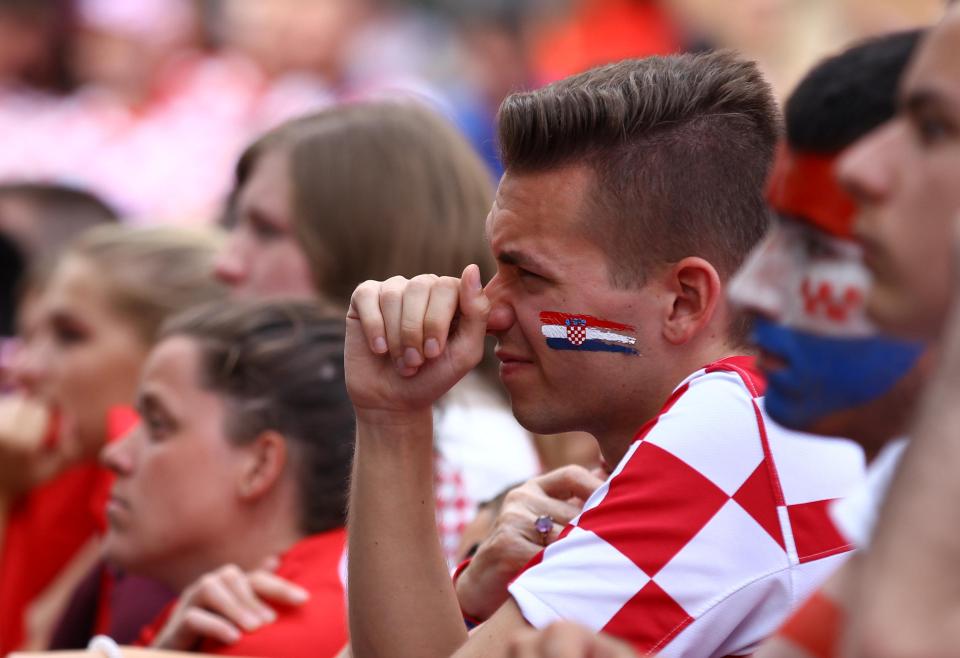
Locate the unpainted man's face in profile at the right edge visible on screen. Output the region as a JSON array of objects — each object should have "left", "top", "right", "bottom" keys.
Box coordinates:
[{"left": 839, "top": 8, "right": 960, "bottom": 338}]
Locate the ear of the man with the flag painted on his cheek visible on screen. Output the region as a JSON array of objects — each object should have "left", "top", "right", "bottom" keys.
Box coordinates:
[{"left": 663, "top": 256, "right": 724, "bottom": 345}]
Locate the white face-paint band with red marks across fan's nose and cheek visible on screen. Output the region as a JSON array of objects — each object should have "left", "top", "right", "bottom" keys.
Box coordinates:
[{"left": 729, "top": 219, "right": 876, "bottom": 337}]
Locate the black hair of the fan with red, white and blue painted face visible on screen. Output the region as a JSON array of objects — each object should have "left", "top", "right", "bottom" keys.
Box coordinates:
[{"left": 784, "top": 30, "right": 925, "bottom": 154}]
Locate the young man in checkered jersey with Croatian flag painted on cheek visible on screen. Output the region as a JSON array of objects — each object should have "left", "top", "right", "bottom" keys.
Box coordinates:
[{"left": 345, "top": 53, "right": 861, "bottom": 657}]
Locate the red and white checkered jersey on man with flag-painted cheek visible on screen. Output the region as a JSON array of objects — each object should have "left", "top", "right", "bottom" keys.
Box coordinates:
[{"left": 510, "top": 357, "right": 864, "bottom": 657}]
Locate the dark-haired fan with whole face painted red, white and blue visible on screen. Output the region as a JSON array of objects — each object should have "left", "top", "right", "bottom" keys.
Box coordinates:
[{"left": 730, "top": 31, "right": 929, "bottom": 658}]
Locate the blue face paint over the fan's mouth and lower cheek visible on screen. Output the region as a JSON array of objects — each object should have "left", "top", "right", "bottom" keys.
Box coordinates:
[{"left": 752, "top": 317, "right": 923, "bottom": 430}]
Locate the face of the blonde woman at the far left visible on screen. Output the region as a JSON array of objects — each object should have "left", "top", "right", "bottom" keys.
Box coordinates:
[{"left": 12, "top": 256, "right": 147, "bottom": 454}]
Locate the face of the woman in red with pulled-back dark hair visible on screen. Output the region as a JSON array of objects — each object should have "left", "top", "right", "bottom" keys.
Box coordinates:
[{"left": 102, "top": 337, "right": 244, "bottom": 587}]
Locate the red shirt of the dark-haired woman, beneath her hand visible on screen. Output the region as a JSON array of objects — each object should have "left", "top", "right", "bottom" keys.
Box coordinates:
[{"left": 139, "top": 528, "right": 347, "bottom": 658}]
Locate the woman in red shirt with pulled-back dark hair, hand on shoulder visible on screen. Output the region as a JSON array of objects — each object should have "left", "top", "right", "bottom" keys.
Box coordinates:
[{"left": 103, "top": 302, "right": 354, "bottom": 657}]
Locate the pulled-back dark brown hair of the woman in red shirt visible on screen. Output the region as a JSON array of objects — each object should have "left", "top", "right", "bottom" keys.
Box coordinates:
[{"left": 161, "top": 300, "right": 354, "bottom": 534}]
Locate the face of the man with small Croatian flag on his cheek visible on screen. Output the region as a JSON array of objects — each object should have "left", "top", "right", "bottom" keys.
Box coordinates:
[{"left": 486, "top": 167, "right": 669, "bottom": 438}]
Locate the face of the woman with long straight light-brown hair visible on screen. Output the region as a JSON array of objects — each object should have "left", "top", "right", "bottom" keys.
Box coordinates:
[{"left": 215, "top": 148, "right": 317, "bottom": 298}]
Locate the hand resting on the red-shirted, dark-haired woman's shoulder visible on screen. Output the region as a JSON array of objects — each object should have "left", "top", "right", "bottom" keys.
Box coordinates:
[{"left": 152, "top": 561, "right": 309, "bottom": 651}]
